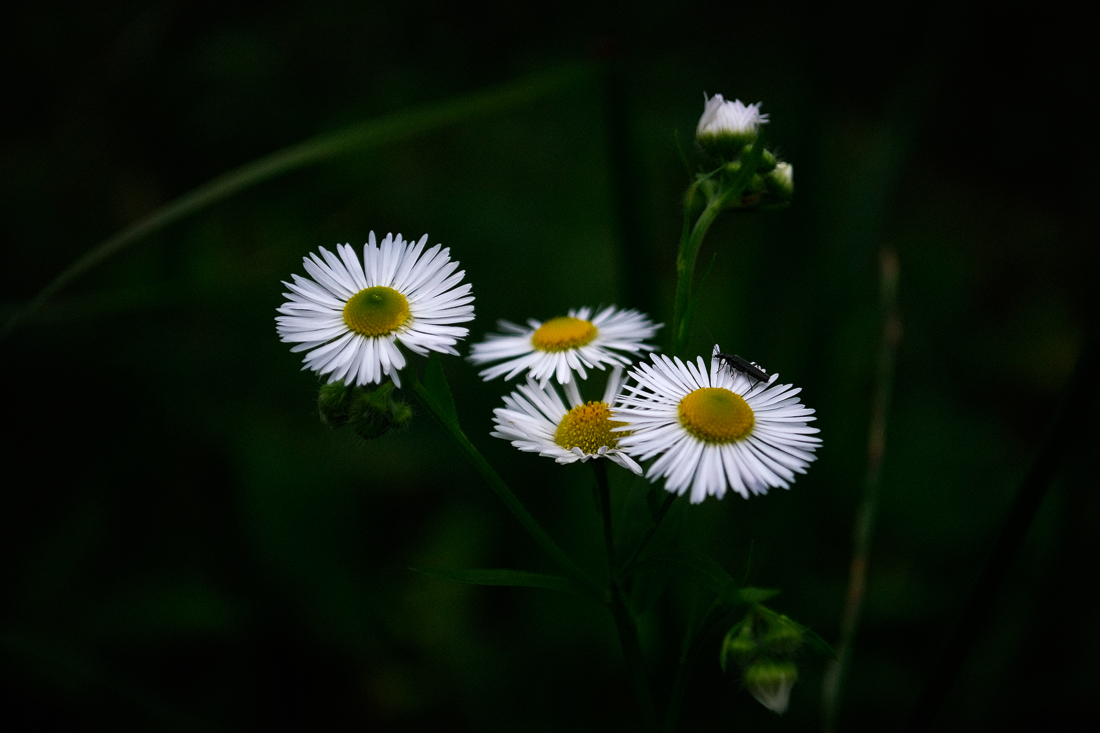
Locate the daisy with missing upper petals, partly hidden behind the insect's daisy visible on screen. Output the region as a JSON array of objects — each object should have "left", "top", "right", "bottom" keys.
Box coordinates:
[{"left": 491, "top": 367, "right": 641, "bottom": 474}]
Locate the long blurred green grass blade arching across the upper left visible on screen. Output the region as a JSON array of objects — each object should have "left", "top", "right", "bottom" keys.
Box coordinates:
[{"left": 0, "top": 65, "right": 590, "bottom": 340}]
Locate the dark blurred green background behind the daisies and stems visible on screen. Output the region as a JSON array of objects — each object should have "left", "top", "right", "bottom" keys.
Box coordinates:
[{"left": 0, "top": 1, "right": 1100, "bottom": 731}]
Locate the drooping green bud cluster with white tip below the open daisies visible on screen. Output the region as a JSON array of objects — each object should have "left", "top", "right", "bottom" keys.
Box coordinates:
[{"left": 718, "top": 605, "right": 805, "bottom": 714}]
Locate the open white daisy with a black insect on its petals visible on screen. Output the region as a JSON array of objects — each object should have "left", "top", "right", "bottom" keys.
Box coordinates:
[{"left": 616, "top": 348, "right": 821, "bottom": 504}]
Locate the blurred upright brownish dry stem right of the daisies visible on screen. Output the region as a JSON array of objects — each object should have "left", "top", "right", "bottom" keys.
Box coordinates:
[{"left": 822, "top": 250, "right": 901, "bottom": 733}]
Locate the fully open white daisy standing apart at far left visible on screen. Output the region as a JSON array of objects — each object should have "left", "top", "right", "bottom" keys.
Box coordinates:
[{"left": 275, "top": 231, "right": 474, "bottom": 386}]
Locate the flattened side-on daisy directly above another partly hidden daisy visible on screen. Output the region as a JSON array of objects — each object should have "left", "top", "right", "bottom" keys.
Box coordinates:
[{"left": 469, "top": 306, "right": 661, "bottom": 384}]
